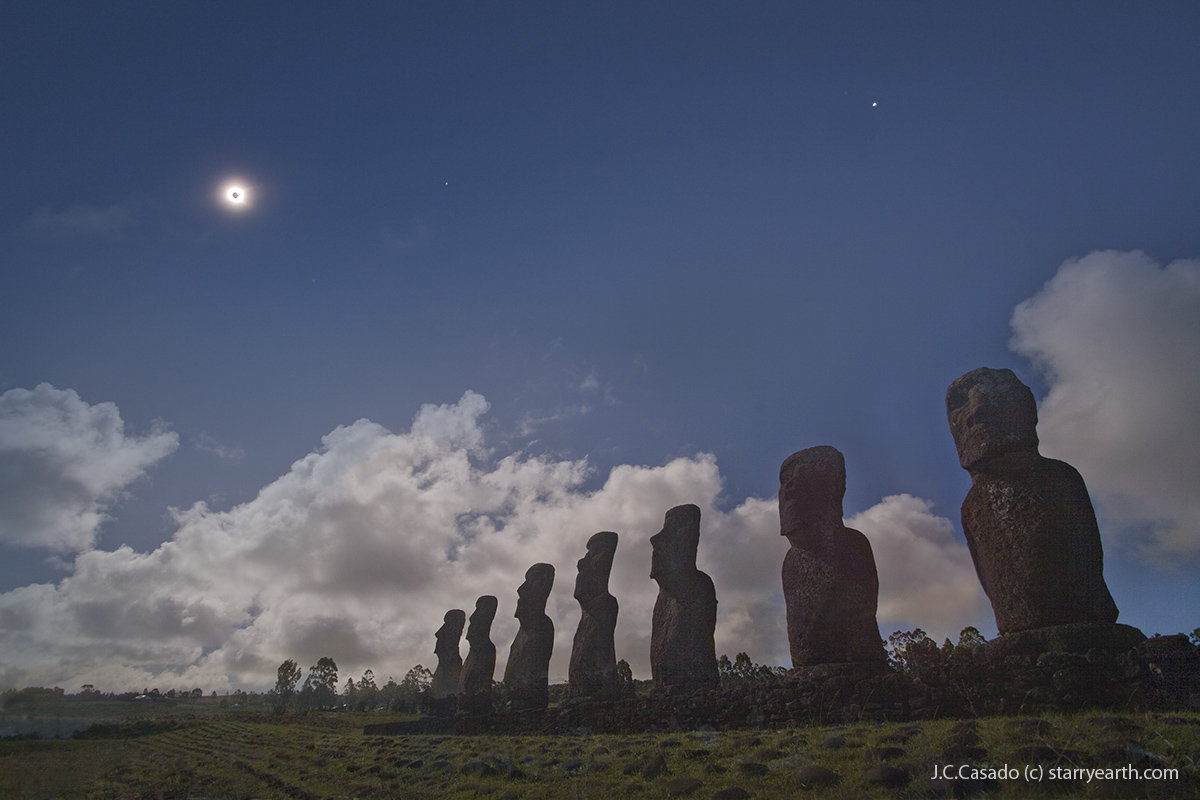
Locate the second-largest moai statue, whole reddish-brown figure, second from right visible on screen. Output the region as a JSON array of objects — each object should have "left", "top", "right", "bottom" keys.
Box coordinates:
[{"left": 779, "top": 445, "right": 887, "bottom": 668}]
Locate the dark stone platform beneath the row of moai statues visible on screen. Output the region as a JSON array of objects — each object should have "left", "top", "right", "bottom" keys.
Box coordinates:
[{"left": 368, "top": 624, "right": 1200, "bottom": 734}]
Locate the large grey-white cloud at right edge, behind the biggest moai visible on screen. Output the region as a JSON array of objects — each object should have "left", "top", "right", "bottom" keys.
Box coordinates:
[{"left": 1012, "top": 251, "right": 1200, "bottom": 565}]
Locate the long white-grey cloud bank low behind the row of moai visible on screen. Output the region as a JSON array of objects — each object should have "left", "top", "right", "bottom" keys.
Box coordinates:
[{"left": 0, "top": 387, "right": 982, "bottom": 690}]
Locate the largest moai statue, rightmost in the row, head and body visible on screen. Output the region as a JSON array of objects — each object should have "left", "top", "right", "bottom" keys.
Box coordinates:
[{"left": 946, "top": 367, "right": 1117, "bottom": 633}]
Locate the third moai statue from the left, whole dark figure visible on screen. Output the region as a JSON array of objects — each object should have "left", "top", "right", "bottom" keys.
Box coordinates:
[{"left": 504, "top": 564, "right": 554, "bottom": 710}]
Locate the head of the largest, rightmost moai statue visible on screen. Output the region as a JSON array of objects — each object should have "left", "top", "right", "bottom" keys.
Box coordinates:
[{"left": 946, "top": 367, "right": 1038, "bottom": 470}]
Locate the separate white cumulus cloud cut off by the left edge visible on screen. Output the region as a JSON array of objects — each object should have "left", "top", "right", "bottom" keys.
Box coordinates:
[{"left": 0, "top": 384, "right": 179, "bottom": 553}]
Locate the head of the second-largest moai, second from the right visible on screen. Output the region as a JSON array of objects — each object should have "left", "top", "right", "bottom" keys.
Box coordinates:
[{"left": 779, "top": 445, "right": 846, "bottom": 547}]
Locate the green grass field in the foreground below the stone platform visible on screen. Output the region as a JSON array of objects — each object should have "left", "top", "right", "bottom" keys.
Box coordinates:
[{"left": 0, "top": 714, "right": 1200, "bottom": 800}]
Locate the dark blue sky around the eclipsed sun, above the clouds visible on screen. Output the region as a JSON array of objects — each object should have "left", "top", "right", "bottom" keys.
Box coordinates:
[{"left": 0, "top": 1, "right": 1200, "bottom": 690}]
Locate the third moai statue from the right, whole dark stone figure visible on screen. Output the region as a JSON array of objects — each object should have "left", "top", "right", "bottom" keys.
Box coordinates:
[{"left": 650, "top": 505, "right": 719, "bottom": 690}]
